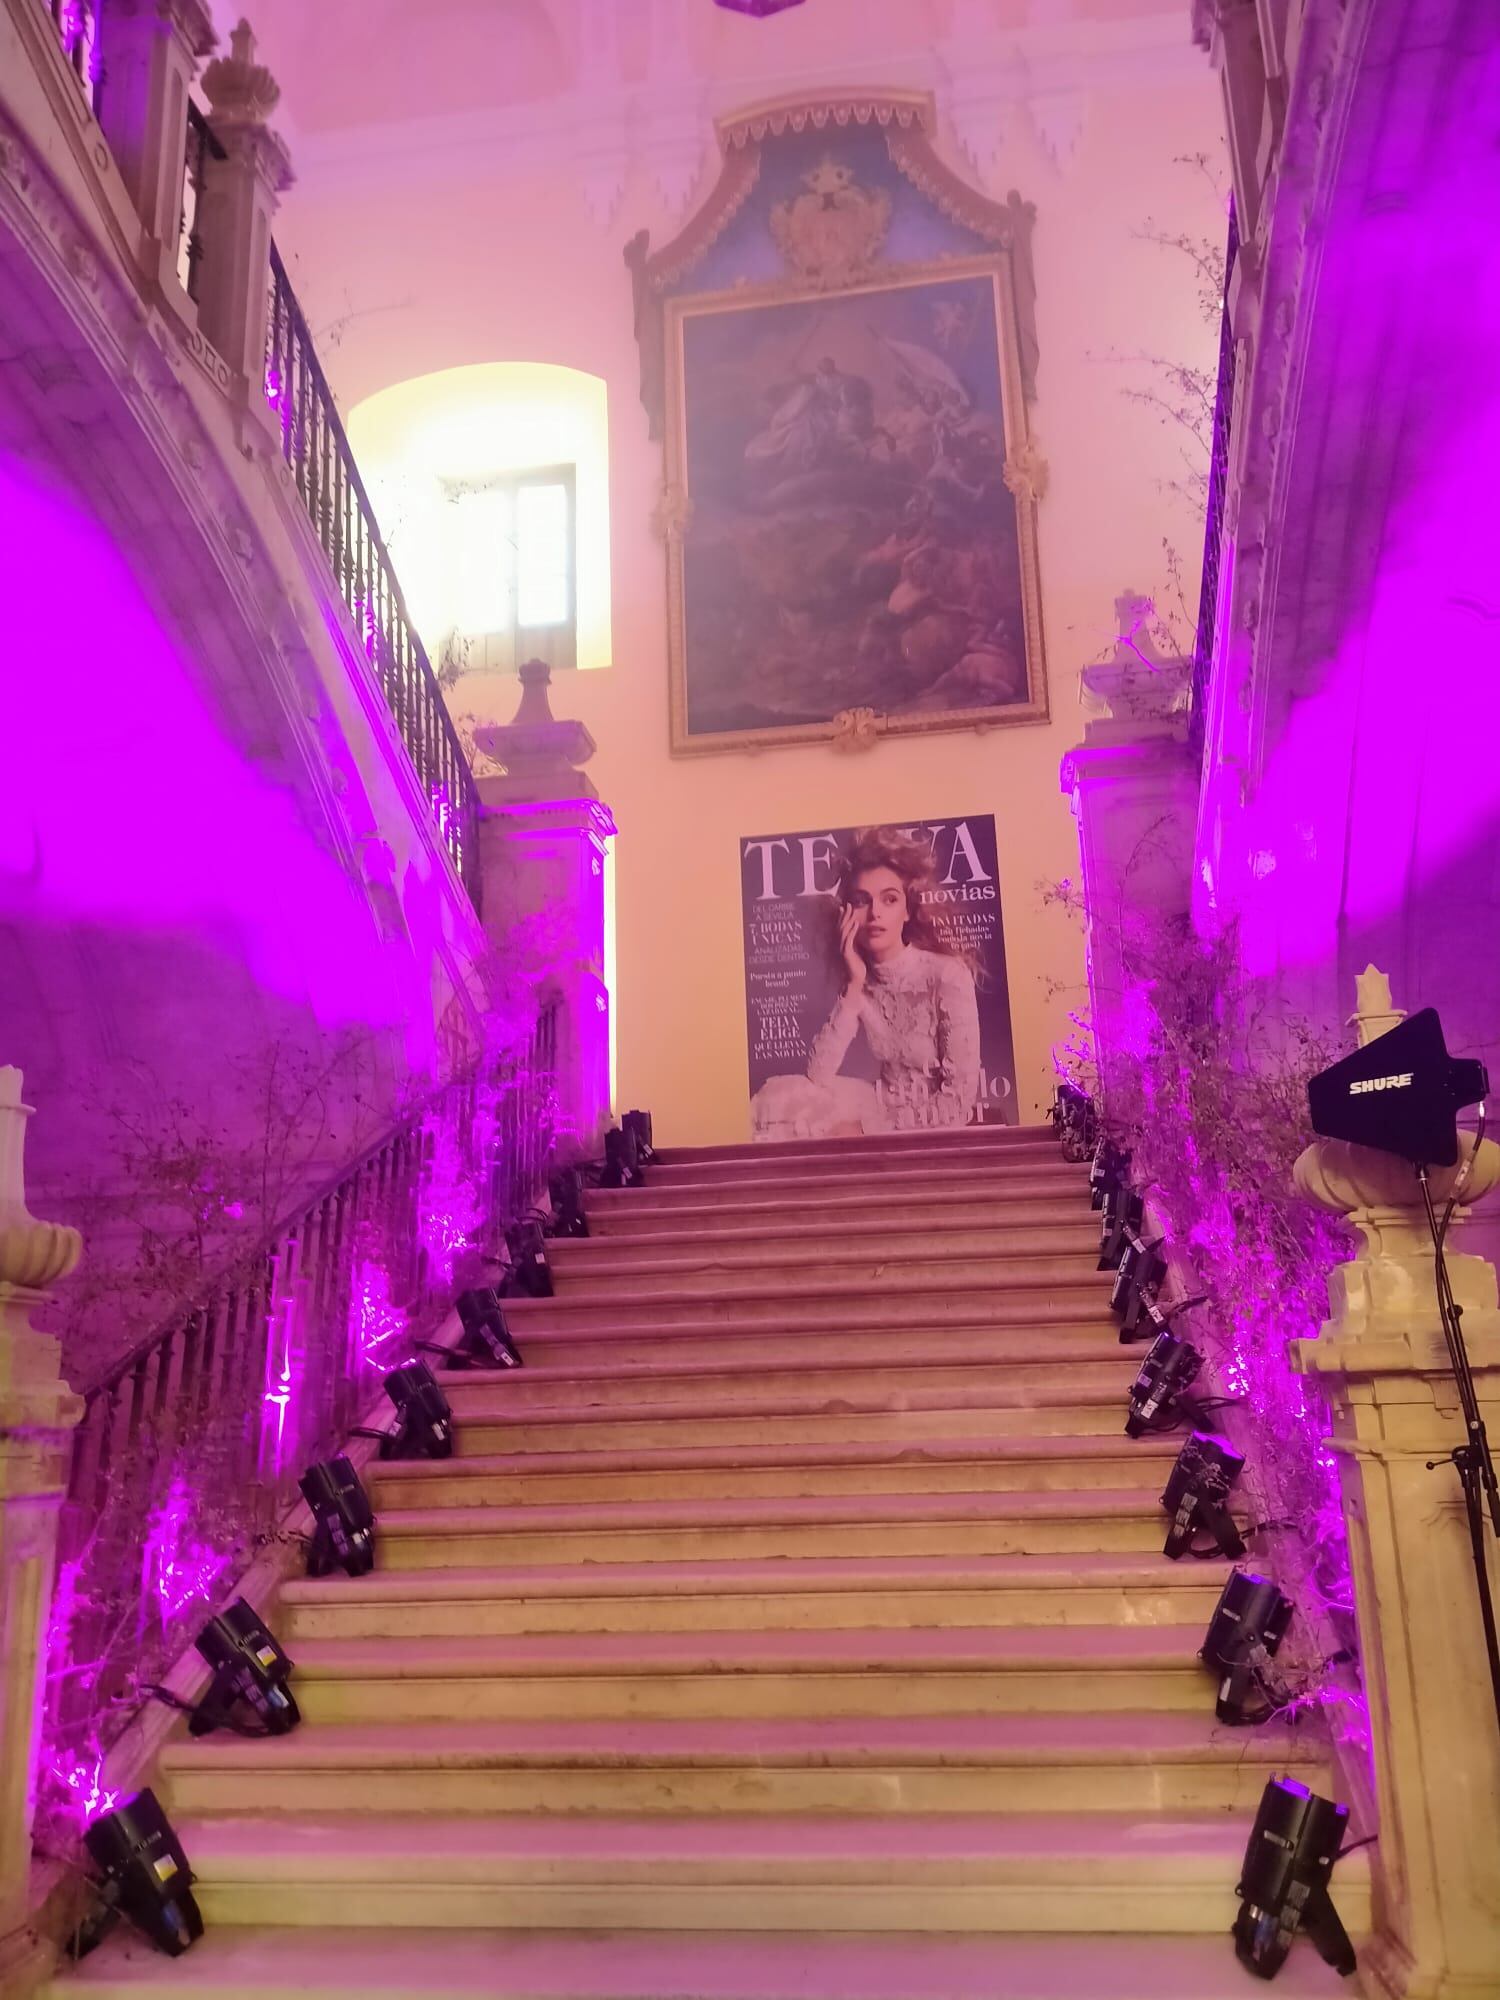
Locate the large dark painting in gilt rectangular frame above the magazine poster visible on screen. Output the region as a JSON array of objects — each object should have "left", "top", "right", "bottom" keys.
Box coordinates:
[{"left": 658, "top": 250, "right": 1048, "bottom": 754}]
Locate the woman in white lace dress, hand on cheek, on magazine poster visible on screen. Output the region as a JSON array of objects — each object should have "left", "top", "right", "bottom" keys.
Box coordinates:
[{"left": 750, "top": 826, "right": 980, "bottom": 1140}]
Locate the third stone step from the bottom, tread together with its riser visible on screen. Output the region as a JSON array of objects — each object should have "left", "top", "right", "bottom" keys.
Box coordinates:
[{"left": 160, "top": 1712, "right": 1326, "bottom": 1816}]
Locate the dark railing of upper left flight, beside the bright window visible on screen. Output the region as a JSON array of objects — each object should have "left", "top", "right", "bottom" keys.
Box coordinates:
[{"left": 266, "top": 246, "right": 480, "bottom": 908}]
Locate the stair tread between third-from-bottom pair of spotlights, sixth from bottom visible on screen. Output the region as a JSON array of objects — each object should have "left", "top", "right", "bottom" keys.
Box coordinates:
[{"left": 370, "top": 1488, "right": 1162, "bottom": 1540}]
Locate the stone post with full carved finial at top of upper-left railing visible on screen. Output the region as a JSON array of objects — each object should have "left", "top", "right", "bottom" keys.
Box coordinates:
[{"left": 198, "top": 20, "right": 292, "bottom": 392}]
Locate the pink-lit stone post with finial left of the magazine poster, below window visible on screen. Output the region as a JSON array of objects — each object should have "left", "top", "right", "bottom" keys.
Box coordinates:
[{"left": 484, "top": 660, "right": 614, "bottom": 1158}]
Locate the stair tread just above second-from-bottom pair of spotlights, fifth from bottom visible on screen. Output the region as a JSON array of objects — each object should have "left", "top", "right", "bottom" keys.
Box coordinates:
[{"left": 280, "top": 1550, "right": 1228, "bottom": 1604}]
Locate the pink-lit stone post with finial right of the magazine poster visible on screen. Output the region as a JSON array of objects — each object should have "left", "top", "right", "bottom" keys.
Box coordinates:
[{"left": 1062, "top": 594, "right": 1198, "bottom": 1112}]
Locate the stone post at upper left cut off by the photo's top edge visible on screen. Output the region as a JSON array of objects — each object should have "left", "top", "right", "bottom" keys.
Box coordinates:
[{"left": 100, "top": 0, "right": 216, "bottom": 288}]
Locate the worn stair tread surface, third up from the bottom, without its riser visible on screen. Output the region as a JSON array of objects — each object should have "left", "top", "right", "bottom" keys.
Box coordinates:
[{"left": 162, "top": 1710, "right": 1326, "bottom": 1774}]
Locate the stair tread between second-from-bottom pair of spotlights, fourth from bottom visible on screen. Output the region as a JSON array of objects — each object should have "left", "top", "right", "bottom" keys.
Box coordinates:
[{"left": 284, "top": 1626, "right": 1212, "bottom": 1692}]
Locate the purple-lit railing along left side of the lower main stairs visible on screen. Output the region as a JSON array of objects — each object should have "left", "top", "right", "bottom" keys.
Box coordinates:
[{"left": 50, "top": 1006, "right": 556, "bottom": 1820}]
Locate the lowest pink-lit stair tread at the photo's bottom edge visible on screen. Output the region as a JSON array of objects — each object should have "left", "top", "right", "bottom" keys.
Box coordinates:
[{"left": 44, "top": 1912, "right": 1348, "bottom": 2000}]
